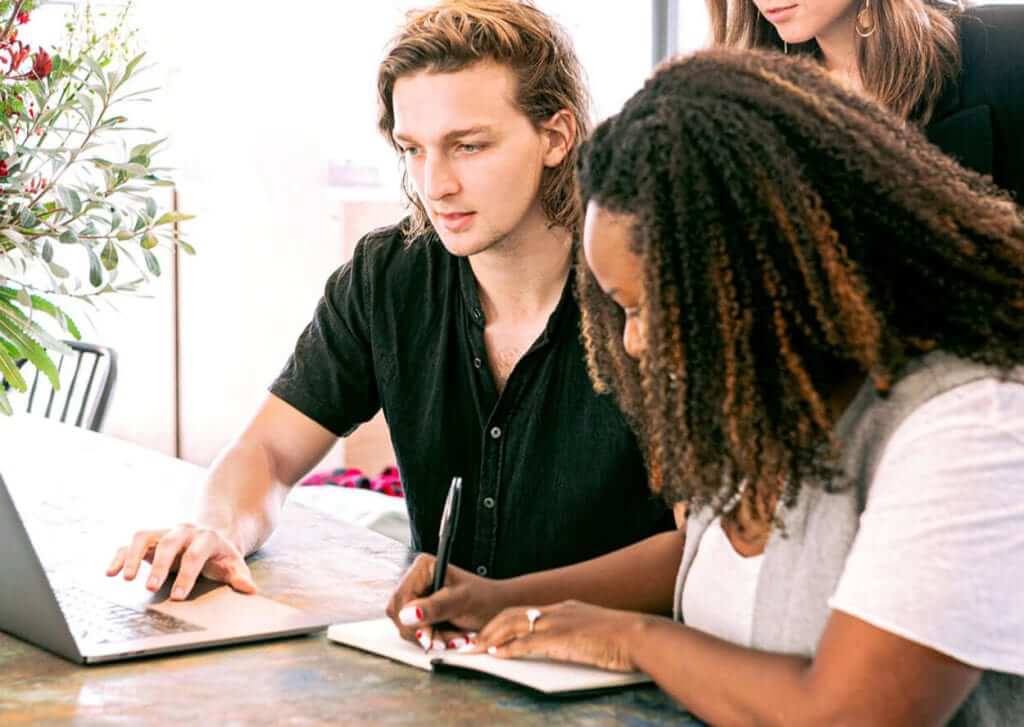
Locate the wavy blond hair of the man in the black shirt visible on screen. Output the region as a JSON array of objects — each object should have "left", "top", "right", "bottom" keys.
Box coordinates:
[{"left": 377, "top": 0, "right": 591, "bottom": 240}]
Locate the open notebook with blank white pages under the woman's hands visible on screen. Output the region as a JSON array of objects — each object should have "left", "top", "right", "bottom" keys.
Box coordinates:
[{"left": 327, "top": 618, "right": 650, "bottom": 694}]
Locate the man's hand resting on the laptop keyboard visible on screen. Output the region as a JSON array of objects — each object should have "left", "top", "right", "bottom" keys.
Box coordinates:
[{"left": 106, "top": 524, "right": 256, "bottom": 601}]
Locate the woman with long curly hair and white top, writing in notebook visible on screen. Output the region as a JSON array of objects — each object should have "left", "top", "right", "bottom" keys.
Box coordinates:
[{"left": 395, "top": 50, "right": 1024, "bottom": 726}]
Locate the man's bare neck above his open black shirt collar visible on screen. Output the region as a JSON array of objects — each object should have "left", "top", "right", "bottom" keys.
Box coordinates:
[{"left": 469, "top": 206, "right": 572, "bottom": 323}]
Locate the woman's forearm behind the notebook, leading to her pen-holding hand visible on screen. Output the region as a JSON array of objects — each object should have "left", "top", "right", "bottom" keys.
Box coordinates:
[{"left": 500, "top": 530, "right": 684, "bottom": 614}]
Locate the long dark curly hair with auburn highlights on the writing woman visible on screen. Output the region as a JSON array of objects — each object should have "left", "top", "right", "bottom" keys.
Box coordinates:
[{"left": 577, "top": 50, "right": 1024, "bottom": 507}]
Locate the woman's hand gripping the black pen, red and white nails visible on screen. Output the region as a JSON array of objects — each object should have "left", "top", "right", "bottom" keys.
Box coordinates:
[{"left": 387, "top": 555, "right": 510, "bottom": 649}]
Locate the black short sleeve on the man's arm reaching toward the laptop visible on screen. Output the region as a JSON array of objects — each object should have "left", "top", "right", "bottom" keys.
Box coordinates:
[{"left": 270, "top": 239, "right": 380, "bottom": 436}]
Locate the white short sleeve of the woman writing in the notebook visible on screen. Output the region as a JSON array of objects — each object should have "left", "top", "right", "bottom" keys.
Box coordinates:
[{"left": 828, "top": 379, "right": 1024, "bottom": 675}]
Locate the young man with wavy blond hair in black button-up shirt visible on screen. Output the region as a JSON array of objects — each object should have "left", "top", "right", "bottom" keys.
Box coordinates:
[{"left": 108, "top": 0, "right": 673, "bottom": 622}]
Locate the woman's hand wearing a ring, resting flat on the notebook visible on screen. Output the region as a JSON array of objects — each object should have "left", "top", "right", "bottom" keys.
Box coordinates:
[{"left": 472, "top": 601, "right": 649, "bottom": 672}]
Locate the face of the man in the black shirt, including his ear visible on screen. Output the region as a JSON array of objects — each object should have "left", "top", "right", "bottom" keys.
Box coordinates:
[{"left": 392, "top": 61, "right": 564, "bottom": 255}]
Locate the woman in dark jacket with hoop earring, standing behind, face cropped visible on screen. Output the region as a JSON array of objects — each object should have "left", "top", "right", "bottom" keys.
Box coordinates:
[{"left": 707, "top": 0, "right": 1024, "bottom": 204}]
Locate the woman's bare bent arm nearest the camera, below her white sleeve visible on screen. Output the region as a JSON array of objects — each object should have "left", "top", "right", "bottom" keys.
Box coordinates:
[{"left": 630, "top": 611, "right": 980, "bottom": 727}]
